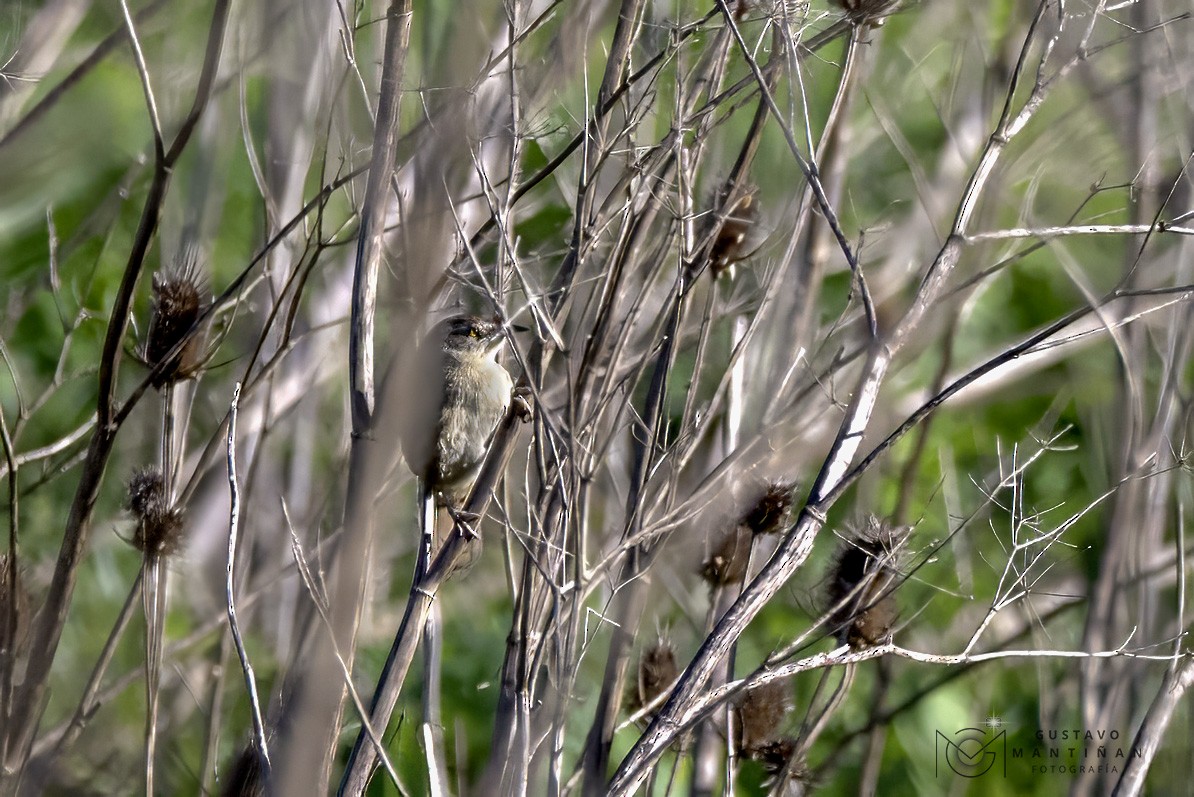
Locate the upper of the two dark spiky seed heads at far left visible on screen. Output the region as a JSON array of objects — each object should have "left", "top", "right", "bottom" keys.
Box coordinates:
[{"left": 143, "top": 254, "right": 208, "bottom": 388}]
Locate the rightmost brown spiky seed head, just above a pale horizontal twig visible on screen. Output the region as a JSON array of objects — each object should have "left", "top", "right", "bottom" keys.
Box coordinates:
[{"left": 826, "top": 517, "right": 906, "bottom": 650}]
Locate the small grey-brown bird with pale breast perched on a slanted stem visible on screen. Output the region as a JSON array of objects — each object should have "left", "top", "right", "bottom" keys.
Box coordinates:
[{"left": 401, "top": 315, "right": 513, "bottom": 555}]
